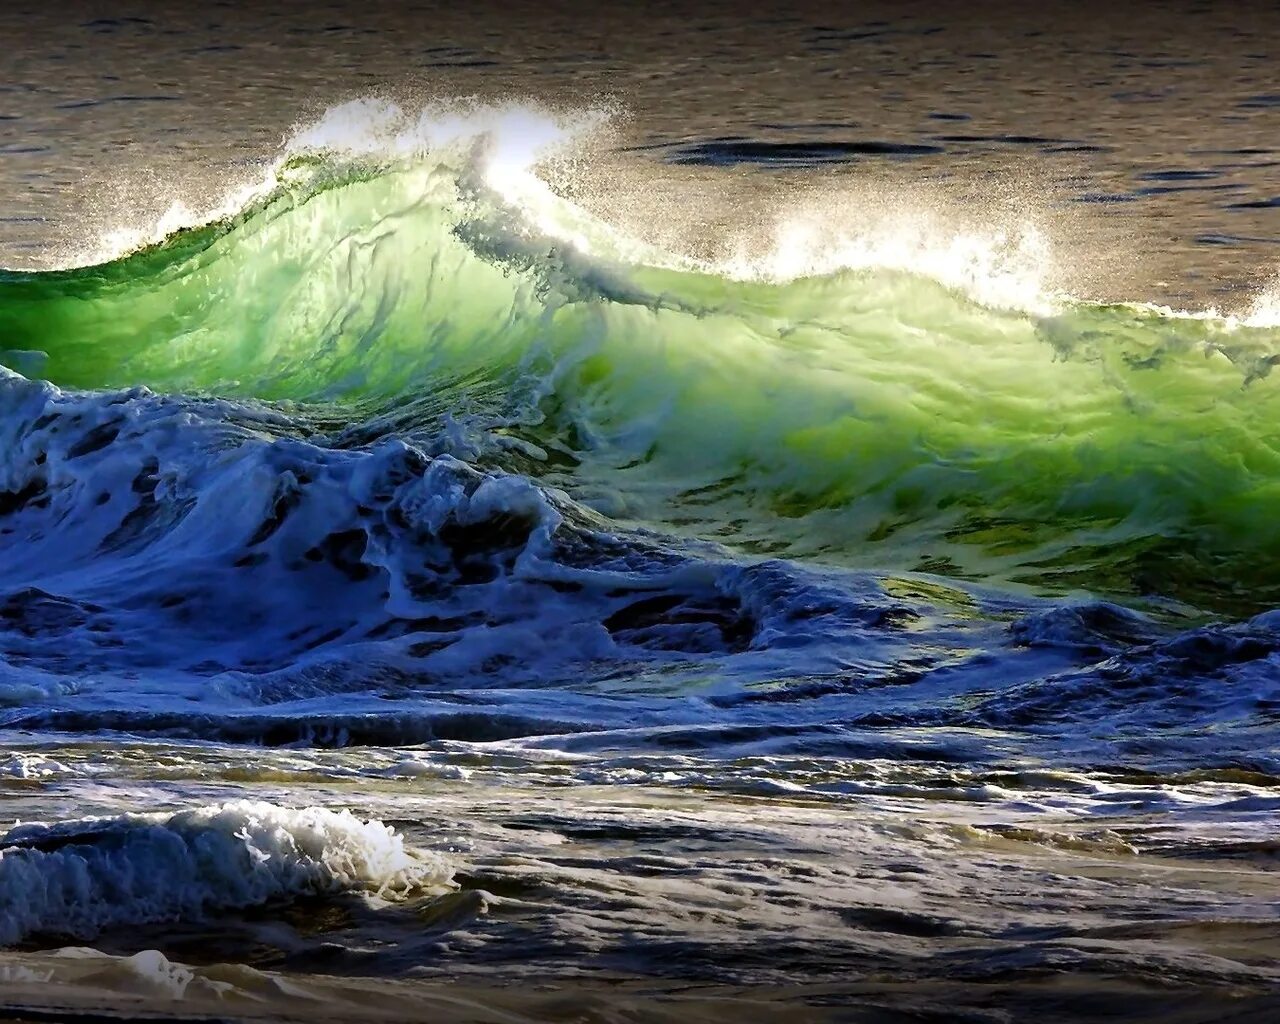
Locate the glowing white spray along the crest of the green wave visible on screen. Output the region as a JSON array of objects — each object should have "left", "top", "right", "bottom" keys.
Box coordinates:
[{"left": 49, "top": 97, "right": 1280, "bottom": 328}]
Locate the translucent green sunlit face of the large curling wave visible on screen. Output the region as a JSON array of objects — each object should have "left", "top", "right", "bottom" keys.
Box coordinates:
[{"left": 0, "top": 147, "right": 1280, "bottom": 609}]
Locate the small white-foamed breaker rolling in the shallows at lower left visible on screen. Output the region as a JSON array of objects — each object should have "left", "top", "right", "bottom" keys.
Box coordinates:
[{"left": 0, "top": 800, "right": 452, "bottom": 946}]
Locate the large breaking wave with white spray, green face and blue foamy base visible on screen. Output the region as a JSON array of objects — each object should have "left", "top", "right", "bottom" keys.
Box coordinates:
[{"left": 0, "top": 104, "right": 1280, "bottom": 771}]
